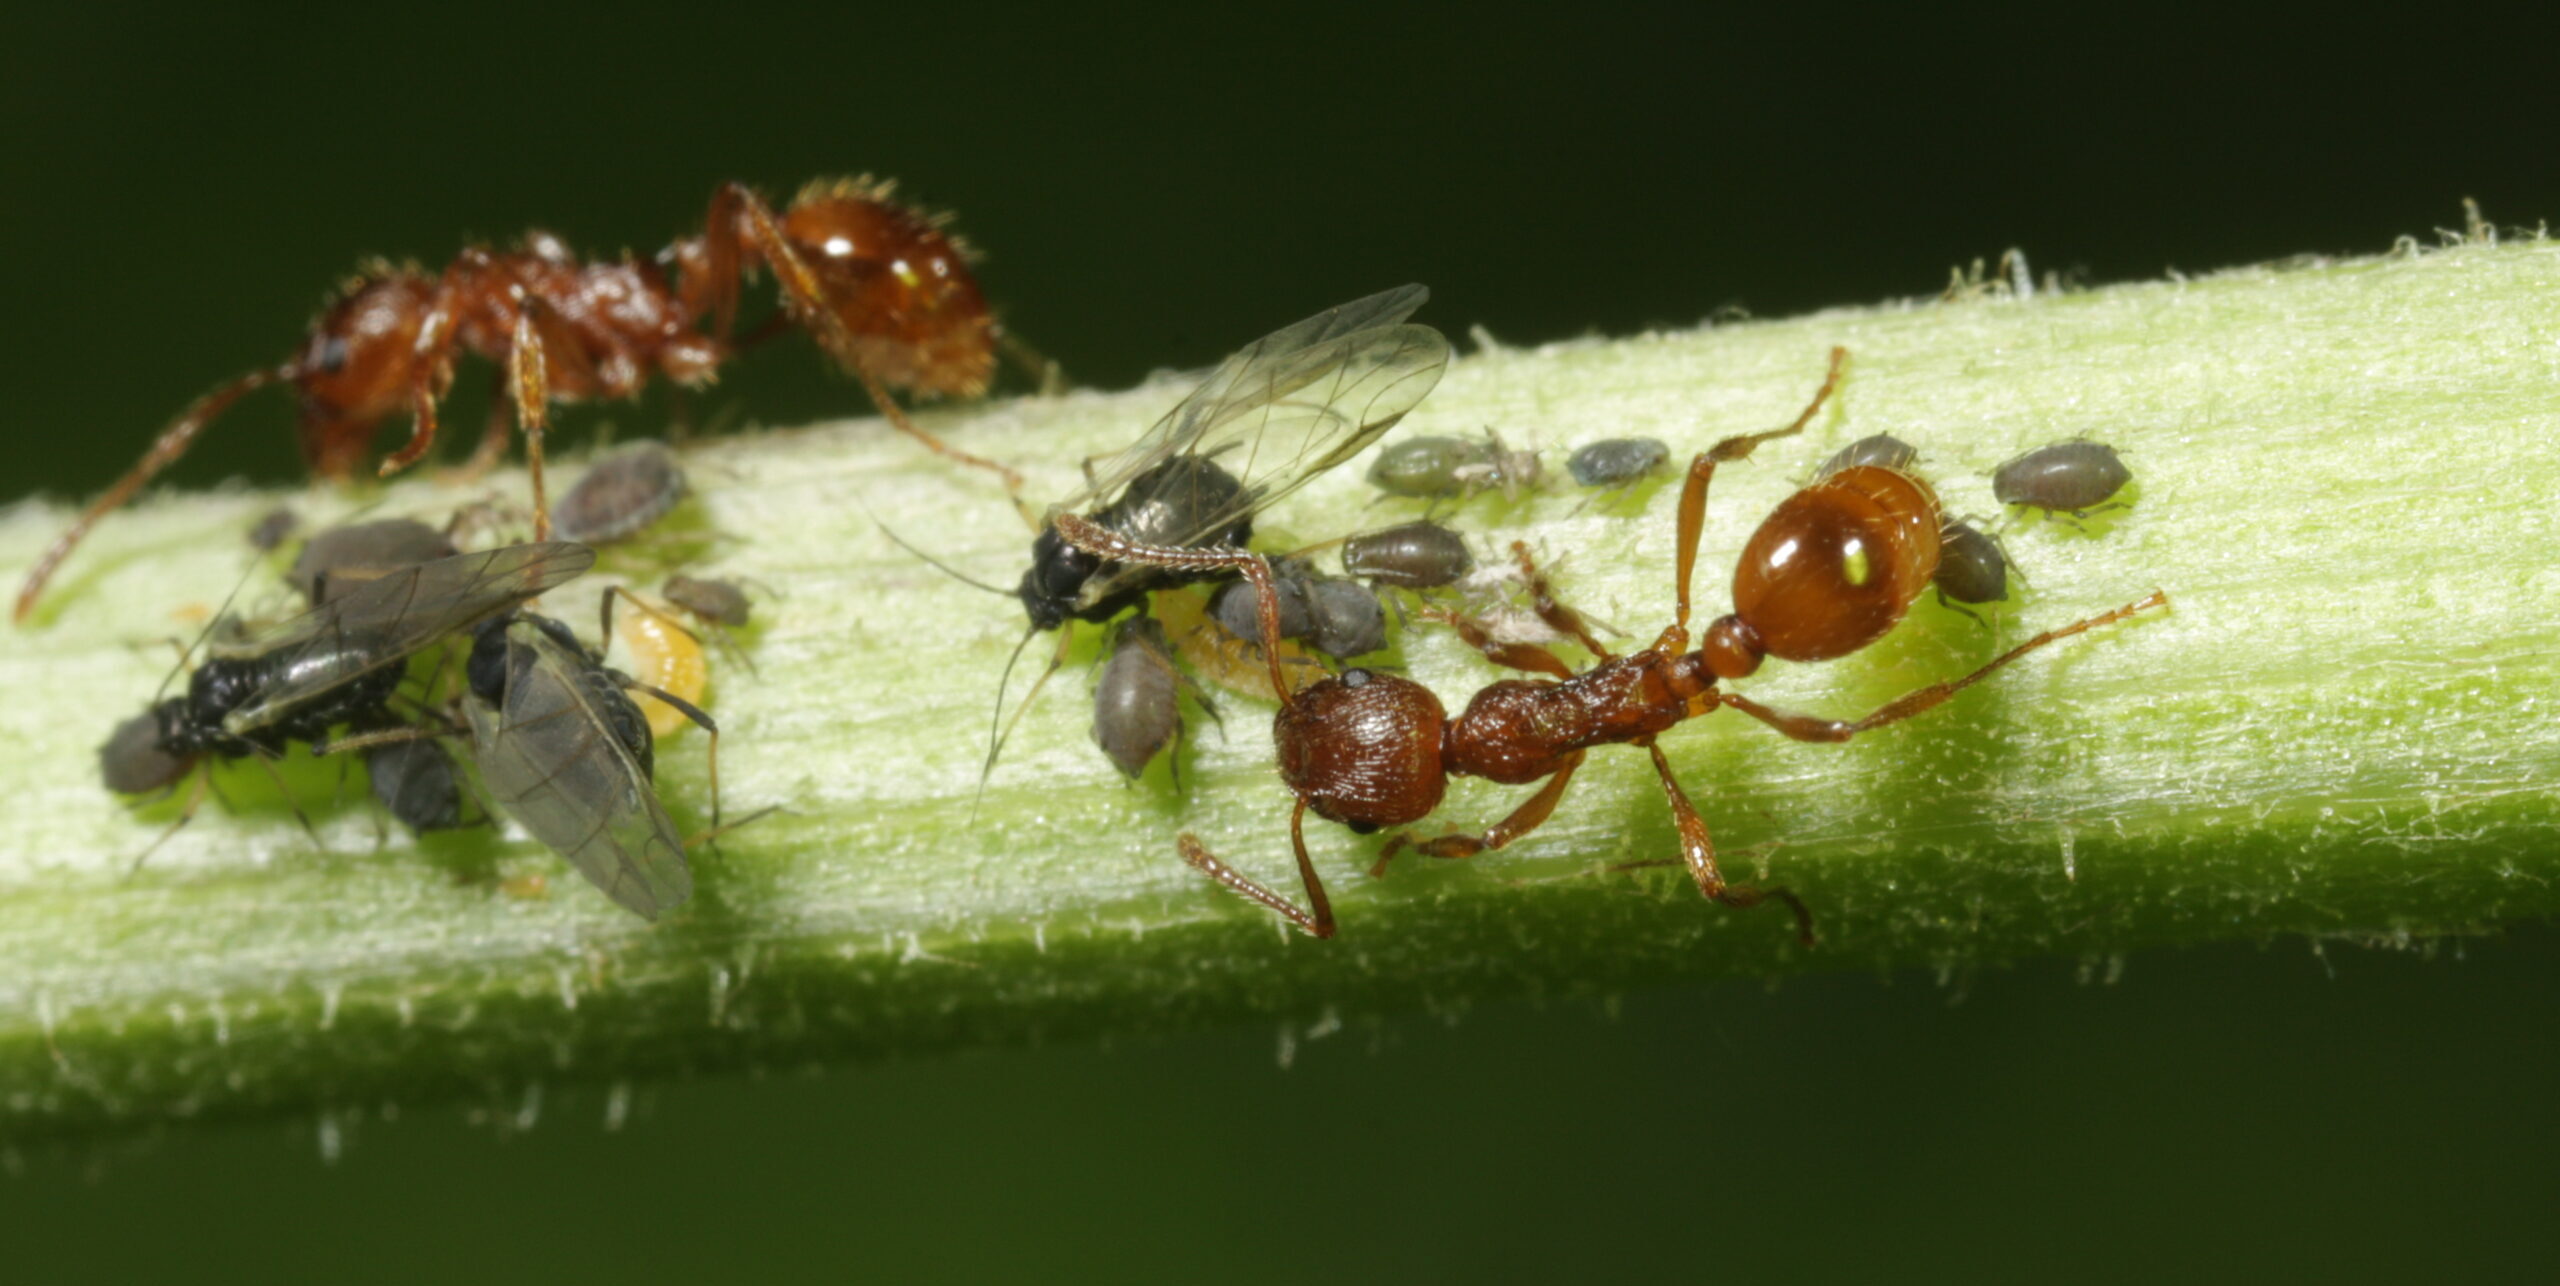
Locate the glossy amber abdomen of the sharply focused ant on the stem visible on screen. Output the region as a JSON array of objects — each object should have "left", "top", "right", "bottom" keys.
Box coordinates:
[{"left": 1713, "top": 464, "right": 1938, "bottom": 660}]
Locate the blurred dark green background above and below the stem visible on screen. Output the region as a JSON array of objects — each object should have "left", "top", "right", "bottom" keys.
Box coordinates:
[{"left": 0, "top": 5, "right": 2560, "bottom": 1283}]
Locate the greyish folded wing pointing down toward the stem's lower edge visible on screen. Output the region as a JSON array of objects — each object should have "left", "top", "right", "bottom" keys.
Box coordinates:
[{"left": 463, "top": 623, "right": 694, "bottom": 920}]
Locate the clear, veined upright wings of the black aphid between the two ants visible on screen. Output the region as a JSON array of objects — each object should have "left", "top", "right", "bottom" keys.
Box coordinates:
[{"left": 1060, "top": 284, "right": 1449, "bottom": 612}]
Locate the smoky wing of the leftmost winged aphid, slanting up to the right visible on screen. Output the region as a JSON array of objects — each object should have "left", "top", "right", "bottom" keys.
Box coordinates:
[{"left": 220, "top": 541, "right": 596, "bottom": 735}]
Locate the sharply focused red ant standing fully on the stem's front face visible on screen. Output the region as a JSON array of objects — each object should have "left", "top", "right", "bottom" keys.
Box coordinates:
[{"left": 1057, "top": 348, "right": 2168, "bottom": 945}]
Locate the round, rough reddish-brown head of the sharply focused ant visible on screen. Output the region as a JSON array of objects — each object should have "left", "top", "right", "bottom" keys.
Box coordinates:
[{"left": 1272, "top": 669, "right": 1449, "bottom": 833}]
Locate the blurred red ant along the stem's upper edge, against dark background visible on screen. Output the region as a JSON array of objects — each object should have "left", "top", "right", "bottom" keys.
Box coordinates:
[{"left": 13, "top": 179, "right": 1034, "bottom": 623}]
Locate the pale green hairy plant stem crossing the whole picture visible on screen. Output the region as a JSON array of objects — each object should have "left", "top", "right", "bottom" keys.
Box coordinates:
[{"left": 0, "top": 243, "right": 2560, "bottom": 1140}]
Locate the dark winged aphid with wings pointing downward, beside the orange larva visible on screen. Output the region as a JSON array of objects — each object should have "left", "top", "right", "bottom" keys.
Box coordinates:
[{"left": 463, "top": 589, "right": 719, "bottom": 920}]
